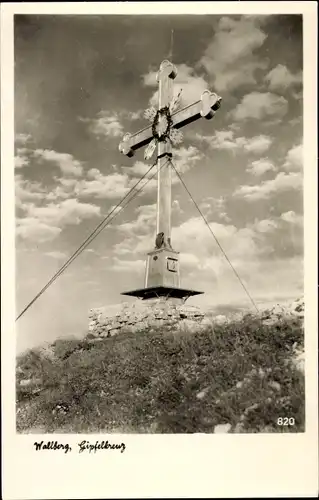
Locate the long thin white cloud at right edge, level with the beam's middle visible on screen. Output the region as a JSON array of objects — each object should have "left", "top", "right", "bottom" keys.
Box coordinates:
[{"left": 234, "top": 172, "right": 302, "bottom": 201}]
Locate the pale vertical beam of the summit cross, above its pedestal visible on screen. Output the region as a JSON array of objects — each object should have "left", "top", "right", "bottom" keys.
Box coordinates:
[{"left": 156, "top": 61, "right": 177, "bottom": 247}]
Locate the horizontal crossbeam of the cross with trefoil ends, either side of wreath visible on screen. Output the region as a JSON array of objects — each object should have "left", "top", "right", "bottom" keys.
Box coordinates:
[{"left": 119, "top": 90, "right": 222, "bottom": 157}]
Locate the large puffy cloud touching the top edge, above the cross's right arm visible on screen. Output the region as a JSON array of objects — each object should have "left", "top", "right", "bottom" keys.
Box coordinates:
[{"left": 200, "top": 16, "right": 268, "bottom": 92}]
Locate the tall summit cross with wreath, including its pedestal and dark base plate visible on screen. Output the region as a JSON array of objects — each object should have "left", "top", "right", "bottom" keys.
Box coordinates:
[{"left": 119, "top": 60, "right": 221, "bottom": 299}]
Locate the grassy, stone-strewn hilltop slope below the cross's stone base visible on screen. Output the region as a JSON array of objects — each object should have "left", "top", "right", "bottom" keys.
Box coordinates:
[{"left": 16, "top": 300, "right": 305, "bottom": 433}]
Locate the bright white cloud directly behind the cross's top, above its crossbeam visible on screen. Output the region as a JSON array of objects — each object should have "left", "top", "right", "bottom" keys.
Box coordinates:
[{"left": 143, "top": 64, "right": 209, "bottom": 108}]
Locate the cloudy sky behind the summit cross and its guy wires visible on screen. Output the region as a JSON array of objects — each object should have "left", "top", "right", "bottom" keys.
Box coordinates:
[{"left": 15, "top": 15, "right": 303, "bottom": 350}]
